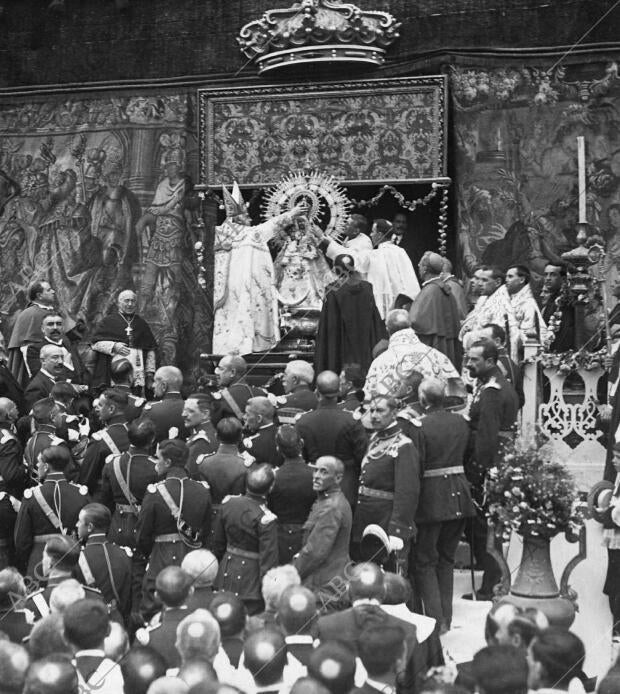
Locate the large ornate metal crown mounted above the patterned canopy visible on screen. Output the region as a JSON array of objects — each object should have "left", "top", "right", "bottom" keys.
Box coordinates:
[{"left": 237, "top": 0, "right": 401, "bottom": 73}]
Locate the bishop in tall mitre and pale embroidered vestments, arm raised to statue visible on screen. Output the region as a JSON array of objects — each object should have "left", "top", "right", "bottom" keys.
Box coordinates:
[{"left": 213, "top": 182, "right": 305, "bottom": 354}]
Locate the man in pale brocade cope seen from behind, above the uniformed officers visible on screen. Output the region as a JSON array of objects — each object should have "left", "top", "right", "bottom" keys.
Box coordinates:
[{"left": 364, "top": 309, "right": 464, "bottom": 399}]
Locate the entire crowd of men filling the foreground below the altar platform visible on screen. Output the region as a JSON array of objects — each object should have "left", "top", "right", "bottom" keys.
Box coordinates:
[{"left": 0, "top": 253, "right": 619, "bottom": 694}]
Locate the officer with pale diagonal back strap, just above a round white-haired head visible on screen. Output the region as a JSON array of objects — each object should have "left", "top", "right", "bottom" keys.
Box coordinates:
[{"left": 137, "top": 439, "right": 211, "bottom": 615}]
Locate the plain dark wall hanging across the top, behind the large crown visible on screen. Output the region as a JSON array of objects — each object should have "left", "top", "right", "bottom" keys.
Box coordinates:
[{"left": 0, "top": 0, "right": 619, "bottom": 87}]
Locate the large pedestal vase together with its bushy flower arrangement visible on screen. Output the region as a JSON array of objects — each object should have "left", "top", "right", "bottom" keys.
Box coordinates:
[{"left": 485, "top": 434, "right": 585, "bottom": 625}]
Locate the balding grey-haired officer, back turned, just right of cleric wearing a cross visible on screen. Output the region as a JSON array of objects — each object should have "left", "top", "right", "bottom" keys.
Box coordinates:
[{"left": 142, "top": 366, "right": 188, "bottom": 442}]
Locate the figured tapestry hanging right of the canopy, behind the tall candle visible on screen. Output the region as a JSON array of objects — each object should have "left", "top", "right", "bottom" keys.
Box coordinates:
[{"left": 450, "top": 63, "right": 620, "bottom": 298}]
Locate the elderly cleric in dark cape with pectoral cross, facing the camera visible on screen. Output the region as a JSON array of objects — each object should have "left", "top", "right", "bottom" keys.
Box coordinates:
[{"left": 91, "top": 289, "right": 157, "bottom": 391}]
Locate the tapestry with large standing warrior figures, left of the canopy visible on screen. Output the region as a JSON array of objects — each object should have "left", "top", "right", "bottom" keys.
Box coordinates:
[{"left": 0, "top": 93, "right": 211, "bottom": 378}]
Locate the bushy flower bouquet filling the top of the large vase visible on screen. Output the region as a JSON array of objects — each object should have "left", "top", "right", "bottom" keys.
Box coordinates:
[{"left": 485, "top": 434, "right": 585, "bottom": 541}]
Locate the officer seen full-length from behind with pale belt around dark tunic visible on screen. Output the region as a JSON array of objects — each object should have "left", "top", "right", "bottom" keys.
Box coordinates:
[{"left": 410, "top": 378, "right": 475, "bottom": 633}]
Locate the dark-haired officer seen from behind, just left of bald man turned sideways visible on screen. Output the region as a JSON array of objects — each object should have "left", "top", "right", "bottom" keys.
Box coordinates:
[{"left": 269, "top": 424, "right": 316, "bottom": 564}]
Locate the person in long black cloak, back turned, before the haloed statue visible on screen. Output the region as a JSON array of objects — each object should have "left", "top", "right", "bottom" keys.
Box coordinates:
[{"left": 314, "top": 254, "right": 387, "bottom": 373}]
